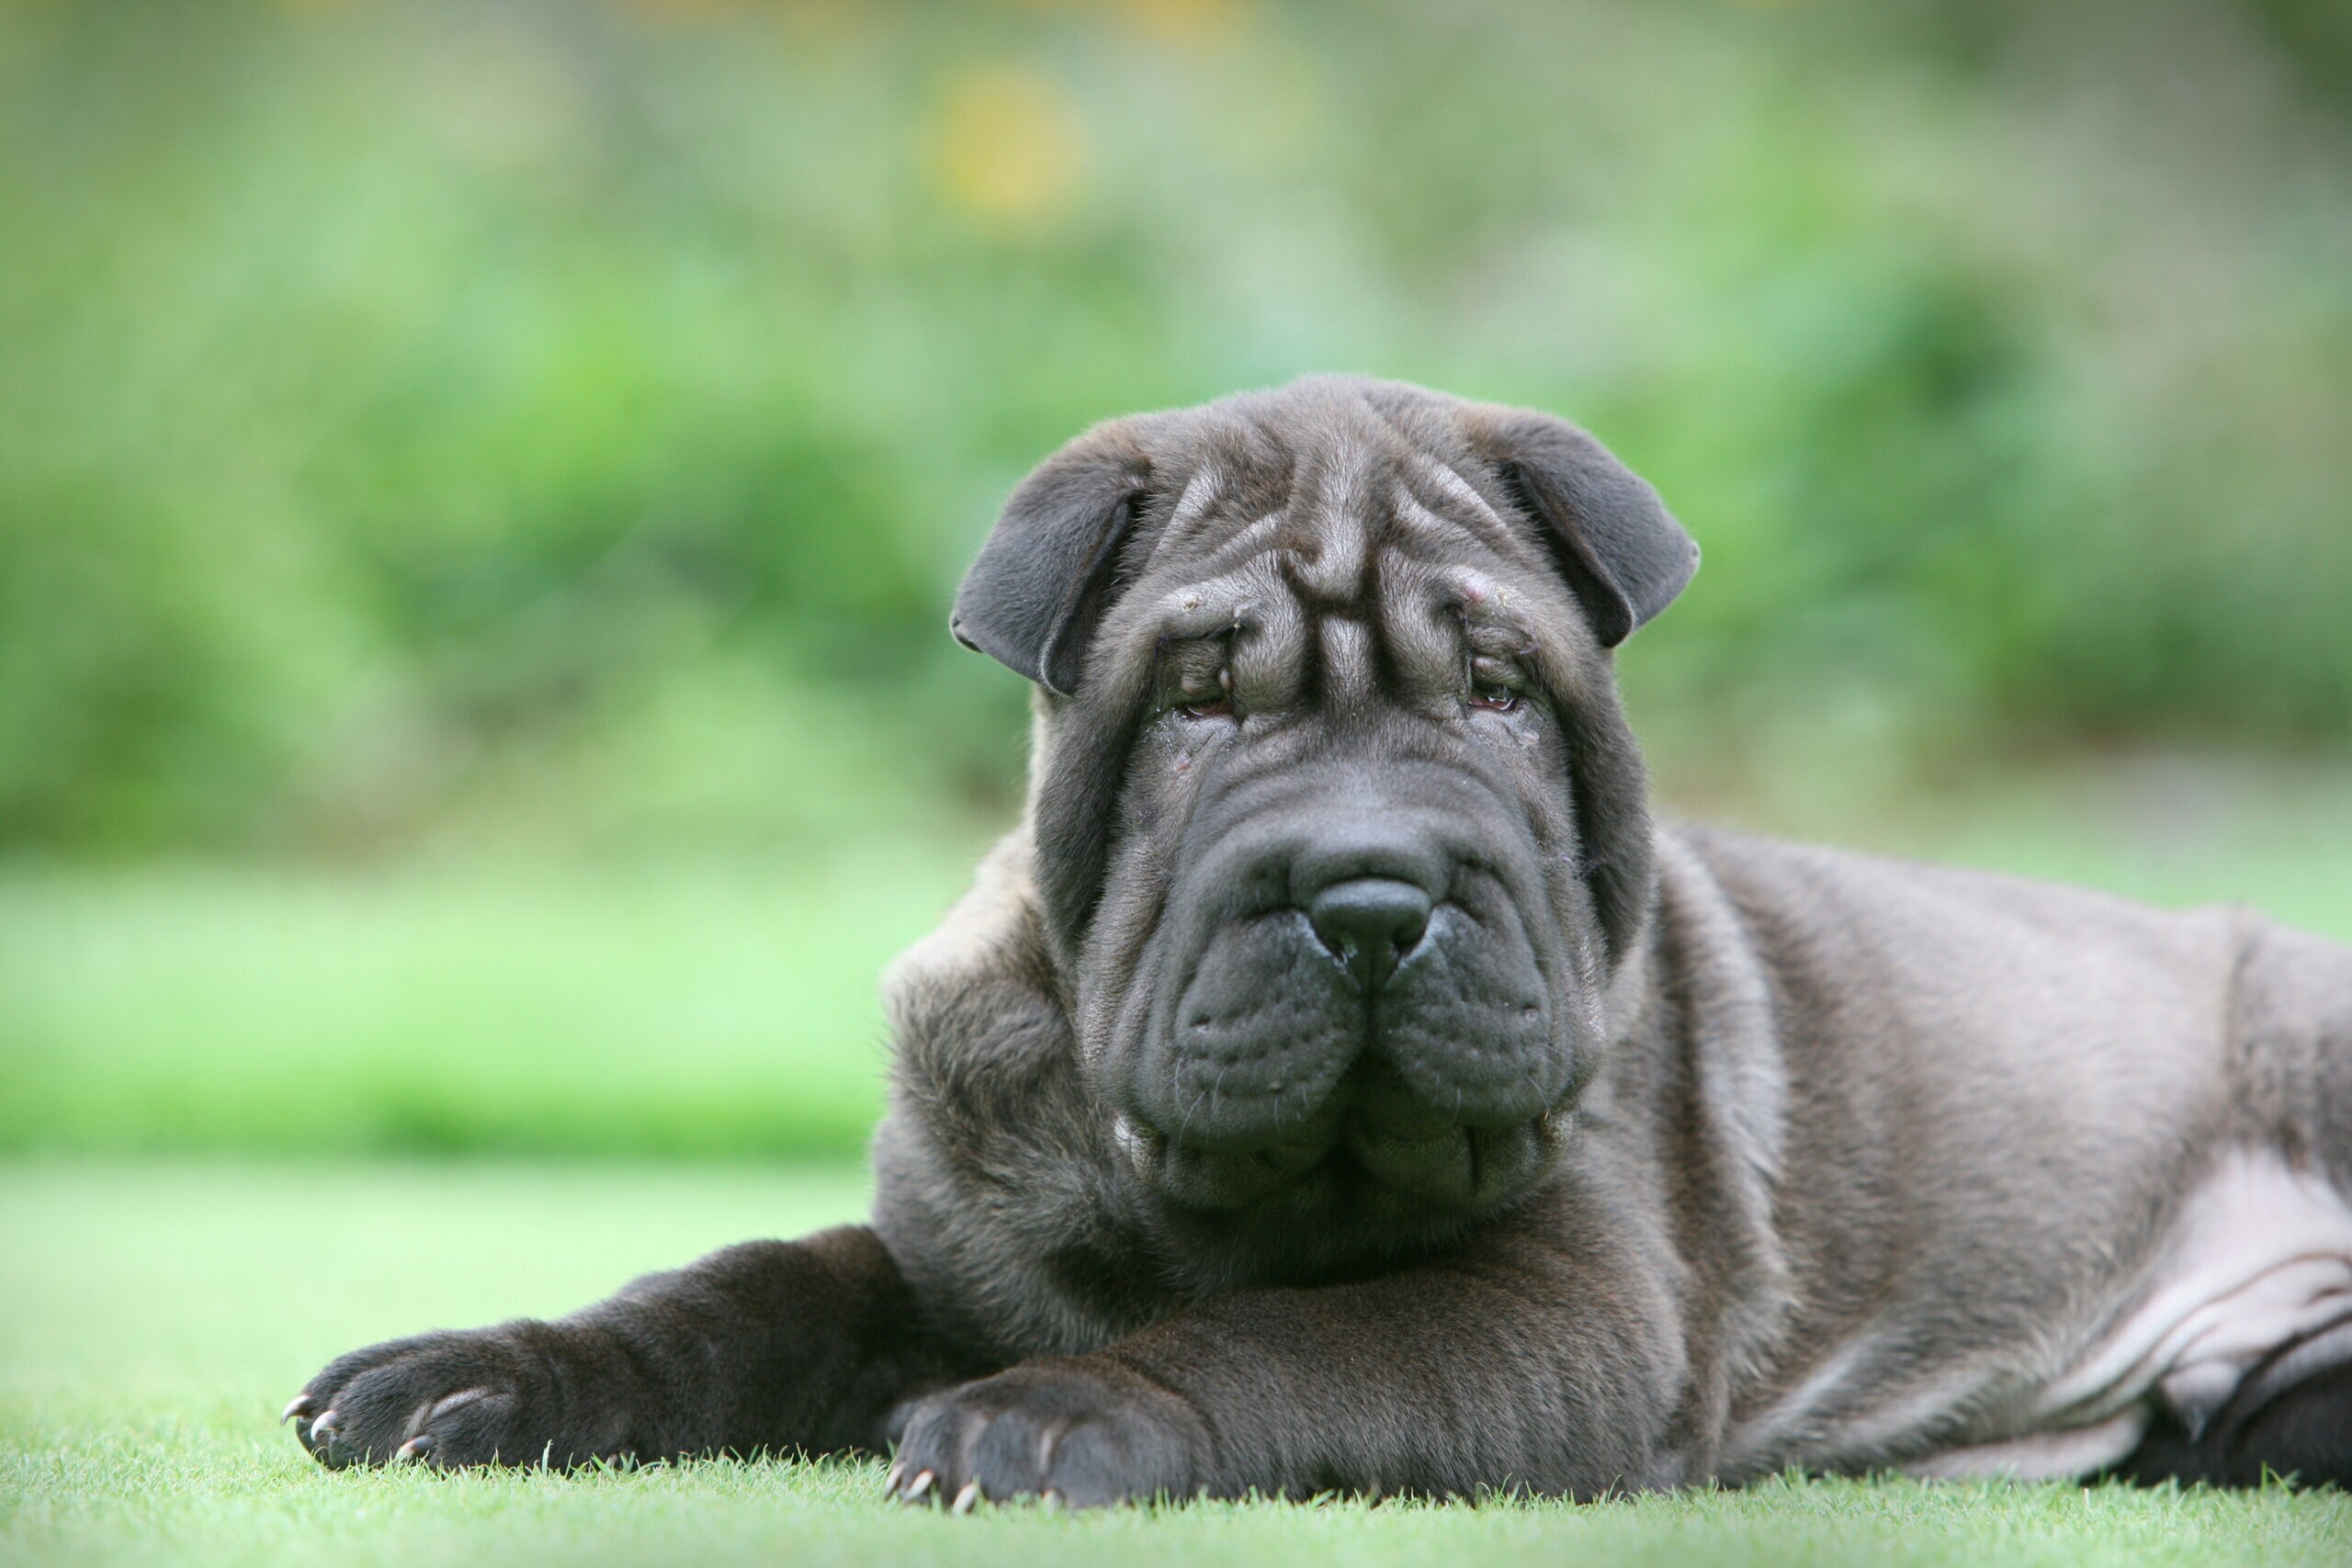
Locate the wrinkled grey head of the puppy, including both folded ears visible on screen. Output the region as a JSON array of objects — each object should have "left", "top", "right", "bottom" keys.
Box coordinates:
[{"left": 955, "top": 378, "right": 1698, "bottom": 1251}]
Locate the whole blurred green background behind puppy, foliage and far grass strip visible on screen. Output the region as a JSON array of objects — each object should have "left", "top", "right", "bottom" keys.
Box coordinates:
[{"left": 0, "top": 0, "right": 2352, "bottom": 1155}]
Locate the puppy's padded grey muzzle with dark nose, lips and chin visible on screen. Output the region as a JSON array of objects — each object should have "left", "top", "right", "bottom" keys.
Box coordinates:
[{"left": 1117, "top": 861, "right": 1574, "bottom": 1208}]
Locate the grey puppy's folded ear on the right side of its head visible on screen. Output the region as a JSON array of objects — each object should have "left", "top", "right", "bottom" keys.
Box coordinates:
[{"left": 1465, "top": 407, "right": 1698, "bottom": 649}]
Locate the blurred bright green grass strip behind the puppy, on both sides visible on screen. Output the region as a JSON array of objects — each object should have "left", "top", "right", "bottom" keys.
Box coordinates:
[{"left": 0, "top": 760, "right": 2352, "bottom": 1156}]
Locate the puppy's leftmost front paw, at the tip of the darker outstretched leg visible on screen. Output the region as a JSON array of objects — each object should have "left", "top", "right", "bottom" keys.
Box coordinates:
[{"left": 285, "top": 1321, "right": 630, "bottom": 1470}]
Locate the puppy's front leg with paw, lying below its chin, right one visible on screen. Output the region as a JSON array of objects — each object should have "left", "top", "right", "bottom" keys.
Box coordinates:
[{"left": 891, "top": 1260, "right": 1679, "bottom": 1506}]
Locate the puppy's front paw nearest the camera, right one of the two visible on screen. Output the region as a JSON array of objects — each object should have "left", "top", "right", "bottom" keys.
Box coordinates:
[{"left": 891, "top": 1357, "right": 1209, "bottom": 1512}]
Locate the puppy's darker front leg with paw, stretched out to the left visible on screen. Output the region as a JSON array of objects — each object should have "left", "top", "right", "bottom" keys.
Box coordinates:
[{"left": 287, "top": 1227, "right": 948, "bottom": 1467}]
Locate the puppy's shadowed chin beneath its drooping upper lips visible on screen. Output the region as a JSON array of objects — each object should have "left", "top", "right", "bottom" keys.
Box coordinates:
[{"left": 1114, "top": 1110, "right": 1566, "bottom": 1229}]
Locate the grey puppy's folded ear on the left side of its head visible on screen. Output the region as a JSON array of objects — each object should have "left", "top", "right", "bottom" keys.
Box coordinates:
[{"left": 948, "top": 421, "right": 1150, "bottom": 696}]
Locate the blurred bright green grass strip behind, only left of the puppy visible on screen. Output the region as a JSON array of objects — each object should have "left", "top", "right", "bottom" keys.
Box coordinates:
[{"left": 0, "top": 844, "right": 976, "bottom": 1156}]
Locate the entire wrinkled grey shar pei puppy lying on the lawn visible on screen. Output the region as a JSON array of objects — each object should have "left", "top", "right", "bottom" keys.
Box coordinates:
[{"left": 287, "top": 378, "right": 2352, "bottom": 1509}]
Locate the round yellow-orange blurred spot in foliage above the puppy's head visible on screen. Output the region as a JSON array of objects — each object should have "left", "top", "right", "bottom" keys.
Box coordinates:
[{"left": 929, "top": 66, "right": 1087, "bottom": 223}]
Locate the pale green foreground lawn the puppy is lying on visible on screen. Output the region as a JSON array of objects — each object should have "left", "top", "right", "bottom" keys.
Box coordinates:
[{"left": 0, "top": 1161, "right": 2352, "bottom": 1568}]
